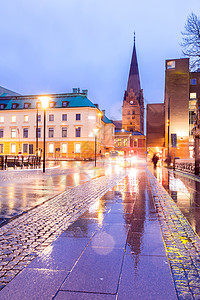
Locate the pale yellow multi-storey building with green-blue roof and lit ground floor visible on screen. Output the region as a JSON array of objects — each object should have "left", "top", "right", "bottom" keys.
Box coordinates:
[{"left": 0, "top": 89, "right": 115, "bottom": 159}]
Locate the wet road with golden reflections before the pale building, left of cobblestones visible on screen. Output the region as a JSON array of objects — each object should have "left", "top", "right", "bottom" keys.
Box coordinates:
[{"left": 0, "top": 162, "right": 105, "bottom": 226}]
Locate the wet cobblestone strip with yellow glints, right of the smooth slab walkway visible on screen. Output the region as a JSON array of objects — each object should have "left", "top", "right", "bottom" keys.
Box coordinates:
[{"left": 149, "top": 172, "right": 200, "bottom": 299}]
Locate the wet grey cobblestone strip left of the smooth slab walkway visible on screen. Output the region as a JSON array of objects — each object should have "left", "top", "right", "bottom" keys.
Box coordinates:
[{"left": 0, "top": 166, "right": 124, "bottom": 288}]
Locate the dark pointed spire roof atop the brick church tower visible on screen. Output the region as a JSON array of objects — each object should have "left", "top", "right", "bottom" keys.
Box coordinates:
[{"left": 127, "top": 36, "right": 141, "bottom": 94}]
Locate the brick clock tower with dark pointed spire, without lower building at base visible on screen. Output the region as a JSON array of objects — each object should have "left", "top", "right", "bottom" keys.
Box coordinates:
[{"left": 122, "top": 35, "right": 144, "bottom": 134}]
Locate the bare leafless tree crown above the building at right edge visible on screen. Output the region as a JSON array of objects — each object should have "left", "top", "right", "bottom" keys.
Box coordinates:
[{"left": 181, "top": 13, "right": 200, "bottom": 71}]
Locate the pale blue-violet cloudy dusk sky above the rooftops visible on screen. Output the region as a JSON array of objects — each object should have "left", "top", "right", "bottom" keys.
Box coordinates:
[{"left": 0, "top": 0, "right": 200, "bottom": 120}]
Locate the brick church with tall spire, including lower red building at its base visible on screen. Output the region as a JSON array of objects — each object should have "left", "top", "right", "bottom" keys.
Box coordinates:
[{"left": 113, "top": 38, "right": 146, "bottom": 157}]
